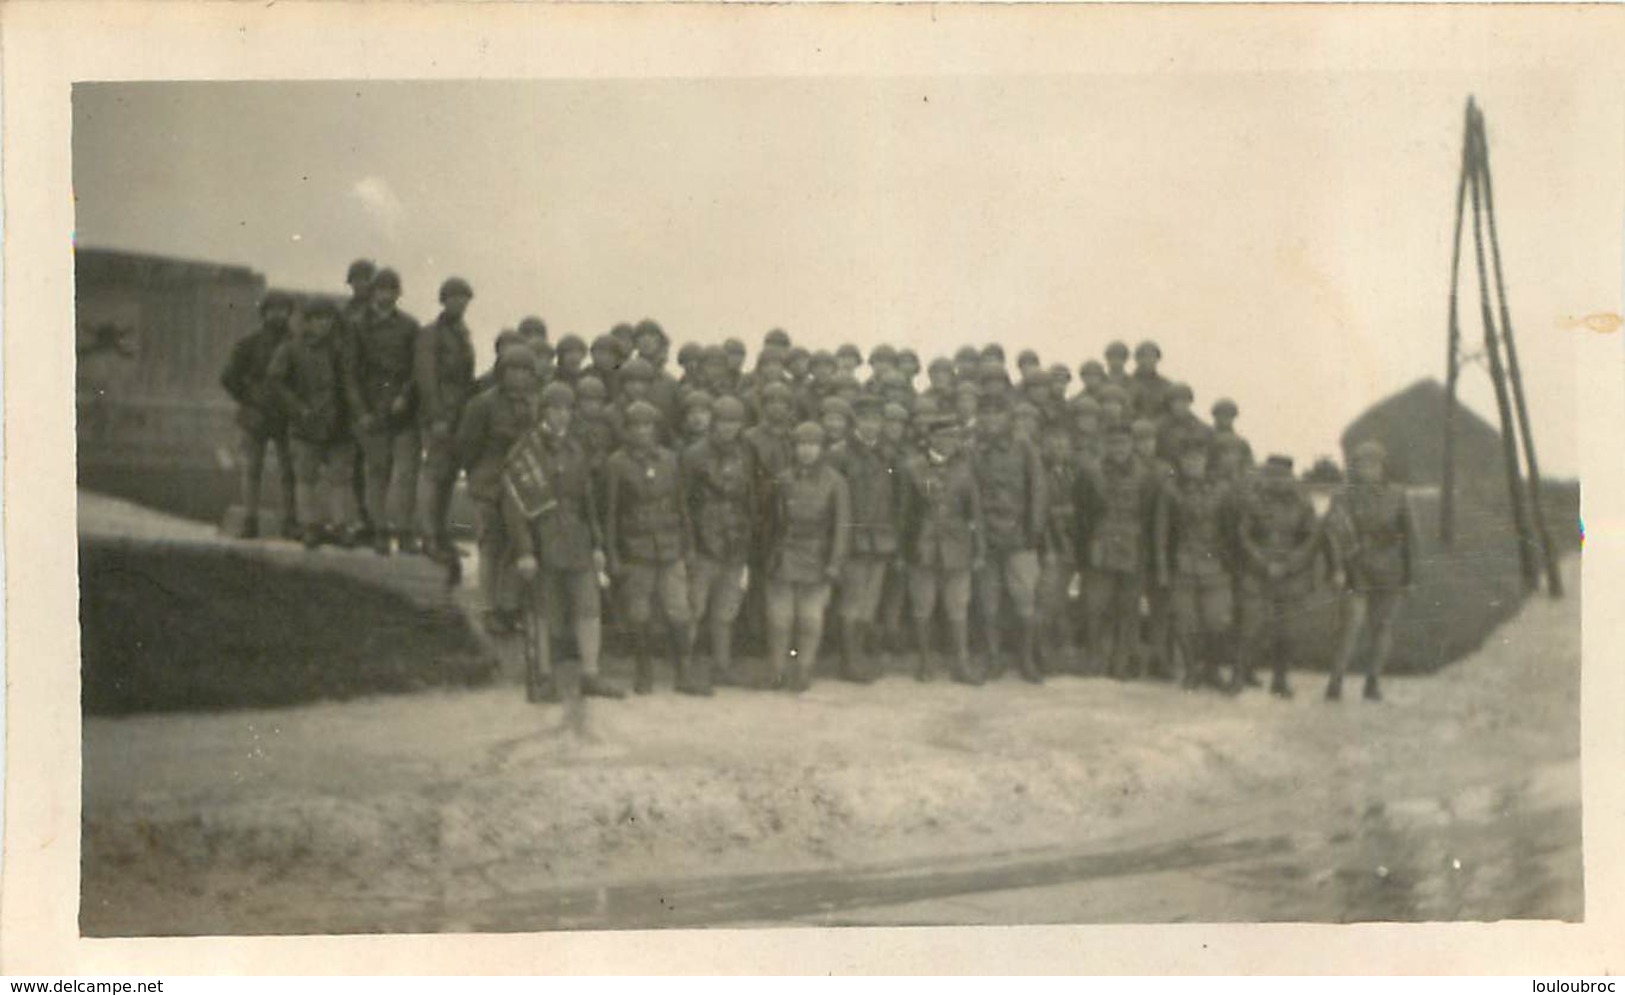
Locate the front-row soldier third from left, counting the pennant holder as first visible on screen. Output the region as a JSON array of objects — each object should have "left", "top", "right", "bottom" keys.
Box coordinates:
[{"left": 683, "top": 397, "right": 761, "bottom": 689}]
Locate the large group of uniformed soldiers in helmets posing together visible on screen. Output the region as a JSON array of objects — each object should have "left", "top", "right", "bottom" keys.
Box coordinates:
[{"left": 223, "top": 260, "right": 1415, "bottom": 699}]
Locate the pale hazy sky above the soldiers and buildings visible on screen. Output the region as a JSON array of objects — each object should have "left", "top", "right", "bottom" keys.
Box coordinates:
[{"left": 73, "top": 73, "right": 1592, "bottom": 475}]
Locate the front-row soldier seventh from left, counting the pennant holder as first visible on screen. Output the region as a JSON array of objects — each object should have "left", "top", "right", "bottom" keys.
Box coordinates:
[{"left": 970, "top": 393, "right": 1048, "bottom": 683}]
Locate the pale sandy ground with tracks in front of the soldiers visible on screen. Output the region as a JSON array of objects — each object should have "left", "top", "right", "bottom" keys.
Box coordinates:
[{"left": 81, "top": 543, "right": 1583, "bottom": 935}]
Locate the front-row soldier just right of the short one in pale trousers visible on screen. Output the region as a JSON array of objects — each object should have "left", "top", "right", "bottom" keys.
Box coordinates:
[{"left": 829, "top": 397, "right": 902, "bottom": 683}]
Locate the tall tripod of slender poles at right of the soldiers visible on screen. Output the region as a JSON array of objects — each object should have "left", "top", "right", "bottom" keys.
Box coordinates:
[{"left": 1438, "top": 98, "right": 1563, "bottom": 598}]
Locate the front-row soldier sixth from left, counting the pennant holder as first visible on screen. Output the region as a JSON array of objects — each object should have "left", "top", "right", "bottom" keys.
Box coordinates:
[{"left": 900, "top": 415, "right": 983, "bottom": 684}]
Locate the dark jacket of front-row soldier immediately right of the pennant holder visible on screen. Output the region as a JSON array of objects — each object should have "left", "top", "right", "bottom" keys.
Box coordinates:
[{"left": 605, "top": 445, "right": 689, "bottom": 563}]
